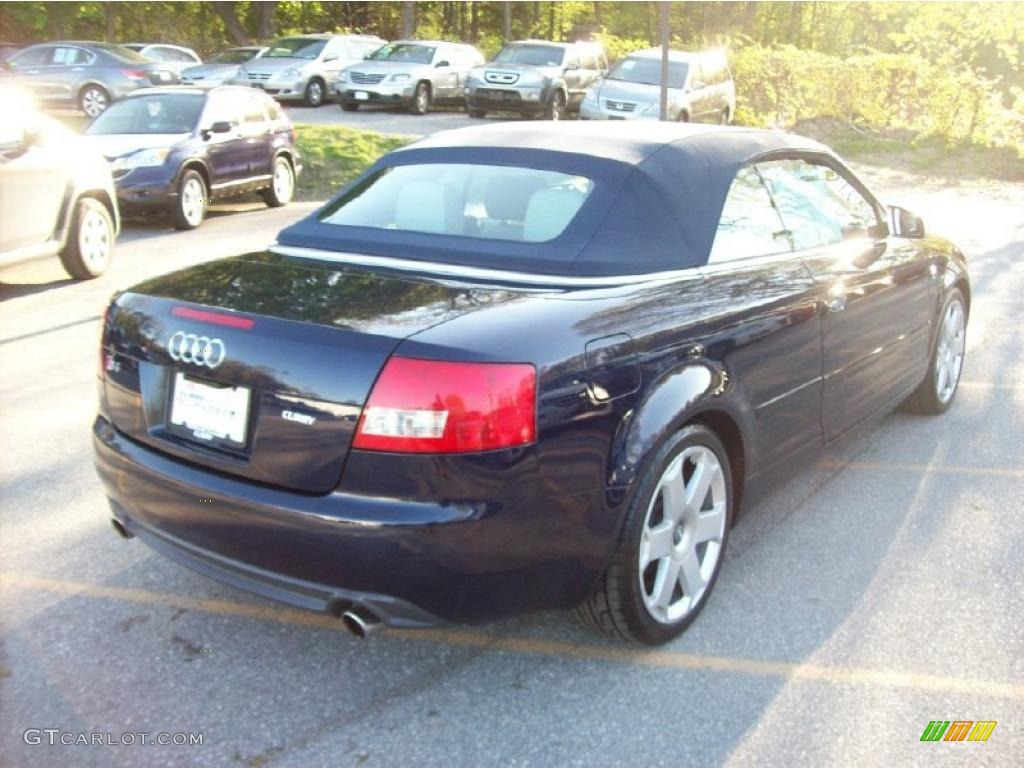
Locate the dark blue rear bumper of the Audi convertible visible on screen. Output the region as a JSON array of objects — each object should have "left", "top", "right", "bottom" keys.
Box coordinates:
[{"left": 93, "top": 417, "right": 614, "bottom": 627}]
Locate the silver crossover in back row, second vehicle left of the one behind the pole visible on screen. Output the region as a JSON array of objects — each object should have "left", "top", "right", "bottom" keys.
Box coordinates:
[{"left": 336, "top": 40, "right": 484, "bottom": 115}]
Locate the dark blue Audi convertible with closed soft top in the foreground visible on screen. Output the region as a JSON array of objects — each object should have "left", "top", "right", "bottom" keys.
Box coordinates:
[{"left": 94, "top": 123, "right": 971, "bottom": 643}]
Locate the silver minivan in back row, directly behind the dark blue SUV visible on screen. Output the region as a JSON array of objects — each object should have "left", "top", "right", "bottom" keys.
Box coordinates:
[{"left": 232, "top": 35, "right": 384, "bottom": 106}]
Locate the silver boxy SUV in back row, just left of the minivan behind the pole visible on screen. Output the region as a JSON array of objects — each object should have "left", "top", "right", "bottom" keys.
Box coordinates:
[{"left": 466, "top": 40, "right": 608, "bottom": 120}]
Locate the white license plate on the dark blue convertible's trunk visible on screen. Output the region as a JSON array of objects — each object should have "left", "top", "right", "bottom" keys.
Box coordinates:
[{"left": 170, "top": 373, "right": 252, "bottom": 447}]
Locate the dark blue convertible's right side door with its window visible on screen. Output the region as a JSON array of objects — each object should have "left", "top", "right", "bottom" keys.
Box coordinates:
[{"left": 758, "top": 156, "right": 937, "bottom": 440}]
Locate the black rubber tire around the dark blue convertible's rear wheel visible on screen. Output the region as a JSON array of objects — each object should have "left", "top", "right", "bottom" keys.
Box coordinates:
[{"left": 577, "top": 424, "right": 734, "bottom": 645}]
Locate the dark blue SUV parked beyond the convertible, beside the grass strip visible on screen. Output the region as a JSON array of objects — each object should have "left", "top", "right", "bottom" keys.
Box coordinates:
[{"left": 85, "top": 86, "right": 302, "bottom": 229}]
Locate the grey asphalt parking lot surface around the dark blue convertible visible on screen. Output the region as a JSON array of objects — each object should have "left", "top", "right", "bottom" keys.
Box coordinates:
[{"left": 0, "top": 169, "right": 1024, "bottom": 768}]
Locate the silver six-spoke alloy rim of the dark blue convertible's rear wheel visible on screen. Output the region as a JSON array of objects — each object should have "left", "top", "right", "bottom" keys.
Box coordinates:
[{"left": 638, "top": 445, "right": 728, "bottom": 624}]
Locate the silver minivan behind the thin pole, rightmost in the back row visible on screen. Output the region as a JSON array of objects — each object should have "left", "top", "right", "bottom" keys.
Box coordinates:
[{"left": 580, "top": 48, "right": 736, "bottom": 125}]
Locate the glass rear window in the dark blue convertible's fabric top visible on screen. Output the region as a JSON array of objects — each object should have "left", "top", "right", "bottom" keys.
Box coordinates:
[{"left": 321, "top": 163, "right": 594, "bottom": 243}]
